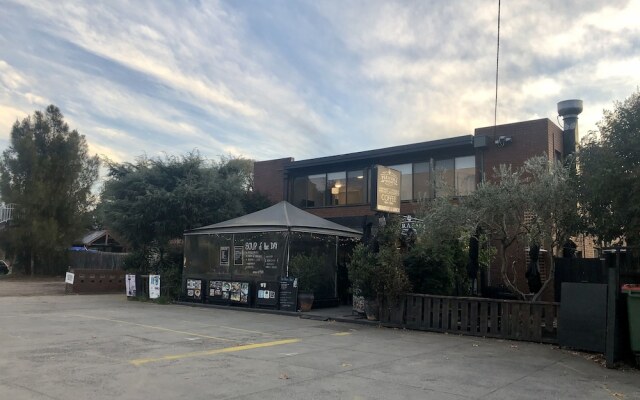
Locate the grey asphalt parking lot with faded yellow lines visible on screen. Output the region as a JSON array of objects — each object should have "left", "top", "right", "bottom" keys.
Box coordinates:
[{"left": 0, "top": 295, "right": 640, "bottom": 400}]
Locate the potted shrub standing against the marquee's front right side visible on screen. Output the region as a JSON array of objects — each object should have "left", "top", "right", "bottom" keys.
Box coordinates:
[{"left": 289, "top": 254, "right": 324, "bottom": 312}]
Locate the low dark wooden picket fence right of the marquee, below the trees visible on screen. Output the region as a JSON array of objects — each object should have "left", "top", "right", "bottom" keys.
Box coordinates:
[{"left": 380, "top": 294, "right": 560, "bottom": 343}]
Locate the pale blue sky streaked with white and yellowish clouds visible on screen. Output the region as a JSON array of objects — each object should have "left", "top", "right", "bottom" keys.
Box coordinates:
[{"left": 0, "top": 0, "right": 640, "bottom": 166}]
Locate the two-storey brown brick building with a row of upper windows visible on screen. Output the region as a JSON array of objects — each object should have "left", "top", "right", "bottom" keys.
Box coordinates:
[{"left": 254, "top": 118, "right": 577, "bottom": 289}]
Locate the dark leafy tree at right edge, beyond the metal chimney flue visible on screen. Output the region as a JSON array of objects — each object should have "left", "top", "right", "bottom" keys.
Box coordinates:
[{"left": 578, "top": 90, "right": 640, "bottom": 245}]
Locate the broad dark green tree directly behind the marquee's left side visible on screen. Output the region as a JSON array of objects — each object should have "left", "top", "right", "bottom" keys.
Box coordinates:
[{"left": 99, "top": 152, "right": 270, "bottom": 296}]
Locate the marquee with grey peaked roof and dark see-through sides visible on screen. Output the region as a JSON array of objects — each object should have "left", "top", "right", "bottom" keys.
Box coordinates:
[{"left": 182, "top": 201, "right": 362, "bottom": 305}]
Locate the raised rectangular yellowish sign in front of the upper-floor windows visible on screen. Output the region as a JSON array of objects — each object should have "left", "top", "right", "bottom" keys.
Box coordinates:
[{"left": 371, "top": 165, "right": 402, "bottom": 214}]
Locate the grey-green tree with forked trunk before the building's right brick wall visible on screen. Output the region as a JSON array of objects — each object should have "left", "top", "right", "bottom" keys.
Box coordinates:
[{"left": 464, "top": 156, "right": 580, "bottom": 299}]
